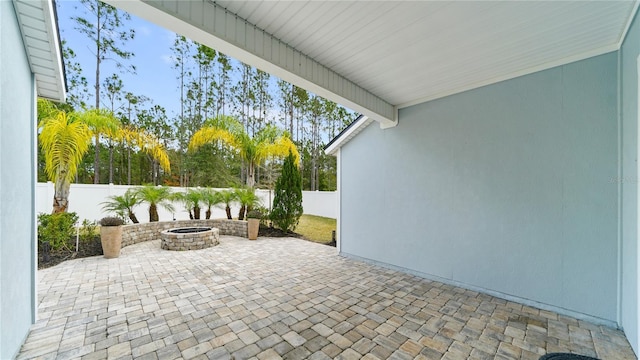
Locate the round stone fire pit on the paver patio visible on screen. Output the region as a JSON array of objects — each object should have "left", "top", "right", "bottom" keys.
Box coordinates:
[{"left": 160, "top": 227, "right": 220, "bottom": 251}]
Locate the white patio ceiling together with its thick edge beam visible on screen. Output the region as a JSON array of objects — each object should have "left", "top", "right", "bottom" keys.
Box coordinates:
[{"left": 105, "top": 0, "right": 638, "bottom": 126}]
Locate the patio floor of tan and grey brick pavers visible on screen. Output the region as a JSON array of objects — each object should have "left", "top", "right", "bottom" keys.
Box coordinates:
[{"left": 19, "top": 236, "right": 635, "bottom": 359}]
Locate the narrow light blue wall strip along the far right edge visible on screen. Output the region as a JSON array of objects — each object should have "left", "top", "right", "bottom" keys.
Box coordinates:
[{"left": 619, "top": 7, "right": 640, "bottom": 354}]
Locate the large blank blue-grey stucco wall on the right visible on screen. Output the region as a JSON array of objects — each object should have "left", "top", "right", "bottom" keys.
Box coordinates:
[{"left": 340, "top": 52, "right": 619, "bottom": 325}]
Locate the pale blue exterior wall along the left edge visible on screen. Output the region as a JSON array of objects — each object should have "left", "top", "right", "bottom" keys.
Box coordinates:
[{"left": 0, "top": 1, "right": 35, "bottom": 359}]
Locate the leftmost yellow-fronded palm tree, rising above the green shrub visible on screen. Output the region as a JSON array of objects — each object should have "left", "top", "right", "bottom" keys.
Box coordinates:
[{"left": 38, "top": 100, "right": 107, "bottom": 213}]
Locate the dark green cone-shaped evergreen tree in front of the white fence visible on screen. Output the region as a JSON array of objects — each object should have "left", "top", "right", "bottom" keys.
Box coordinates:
[{"left": 271, "top": 151, "right": 302, "bottom": 231}]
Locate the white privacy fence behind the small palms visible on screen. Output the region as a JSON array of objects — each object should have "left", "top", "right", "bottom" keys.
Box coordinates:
[{"left": 36, "top": 182, "right": 338, "bottom": 222}]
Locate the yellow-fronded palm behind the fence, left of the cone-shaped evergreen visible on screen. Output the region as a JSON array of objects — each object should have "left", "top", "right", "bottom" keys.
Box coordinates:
[{"left": 189, "top": 115, "right": 300, "bottom": 188}]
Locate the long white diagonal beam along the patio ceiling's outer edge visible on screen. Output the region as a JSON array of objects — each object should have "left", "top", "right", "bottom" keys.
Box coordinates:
[{"left": 105, "top": 0, "right": 397, "bottom": 128}]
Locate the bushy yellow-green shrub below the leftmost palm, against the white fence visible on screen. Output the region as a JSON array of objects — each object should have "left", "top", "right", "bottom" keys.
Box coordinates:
[{"left": 38, "top": 212, "right": 78, "bottom": 250}]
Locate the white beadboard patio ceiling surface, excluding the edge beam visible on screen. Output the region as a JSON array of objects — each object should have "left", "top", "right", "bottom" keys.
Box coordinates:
[{"left": 215, "top": 0, "right": 635, "bottom": 106}]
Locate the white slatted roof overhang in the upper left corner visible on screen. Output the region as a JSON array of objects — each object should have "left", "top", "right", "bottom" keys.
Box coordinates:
[{"left": 13, "top": 0, "right": 66, "bottom": 102}]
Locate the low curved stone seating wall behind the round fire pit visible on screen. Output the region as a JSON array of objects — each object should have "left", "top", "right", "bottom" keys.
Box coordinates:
[{"left": 122, "top": 219, "right": 247, "bottom": 247}]
